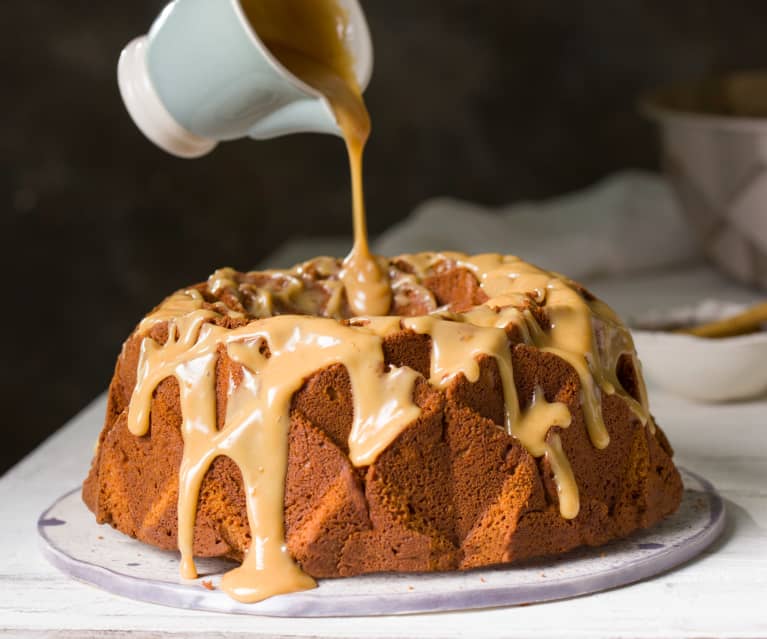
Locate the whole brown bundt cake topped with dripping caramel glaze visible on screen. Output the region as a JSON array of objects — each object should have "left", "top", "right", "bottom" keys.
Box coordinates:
[{"left": 83, "top": 253, "right": 682, "bottom": 601}]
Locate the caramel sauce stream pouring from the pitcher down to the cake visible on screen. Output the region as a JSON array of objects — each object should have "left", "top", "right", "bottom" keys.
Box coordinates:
[{"left": 242, "top": 0, "right": 391, "bottom": 315}]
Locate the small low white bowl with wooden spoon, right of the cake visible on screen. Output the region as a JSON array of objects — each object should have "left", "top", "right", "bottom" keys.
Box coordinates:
[{"left": 630, "top": 300, "right": 767, "bottom": 402}]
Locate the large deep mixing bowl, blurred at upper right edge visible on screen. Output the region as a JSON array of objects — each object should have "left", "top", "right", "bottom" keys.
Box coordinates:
[{"left": 642, "top": 71, "right": 767, "bottom": 288}]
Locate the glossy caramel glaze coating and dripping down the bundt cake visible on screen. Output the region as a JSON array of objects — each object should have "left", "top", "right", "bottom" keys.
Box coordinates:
[{"left": 128, "top": 253, "right": 653, "bottom": 601}]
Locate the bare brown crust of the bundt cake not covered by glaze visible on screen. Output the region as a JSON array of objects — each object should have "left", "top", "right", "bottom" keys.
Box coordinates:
[{"left": 83, "top": 262, "right": 682, "bottom": 577}]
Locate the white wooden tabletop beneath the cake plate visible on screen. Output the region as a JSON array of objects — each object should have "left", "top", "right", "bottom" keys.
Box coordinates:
[{"left": 0, "top": 268, "right": 767, "bottom": 638}]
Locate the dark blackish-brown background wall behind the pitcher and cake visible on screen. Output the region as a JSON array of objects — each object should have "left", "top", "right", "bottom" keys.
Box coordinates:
[{"left": 0, "top": 0, "right": 767, "bottom": 472}]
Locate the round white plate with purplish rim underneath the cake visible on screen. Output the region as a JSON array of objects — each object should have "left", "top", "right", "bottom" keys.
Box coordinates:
[{"left": 38, "top": 469, "right": 725, "bottom": 617}]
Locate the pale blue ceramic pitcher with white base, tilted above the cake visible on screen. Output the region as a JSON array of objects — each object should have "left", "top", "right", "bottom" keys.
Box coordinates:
[{"left": 117, "top": 0, "right": 373, "bottom": 158}]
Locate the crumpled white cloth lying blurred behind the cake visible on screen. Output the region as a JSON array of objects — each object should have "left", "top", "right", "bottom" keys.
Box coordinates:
[{"left": 374, "top": 171, "right": 702, "bottom": 280}]
